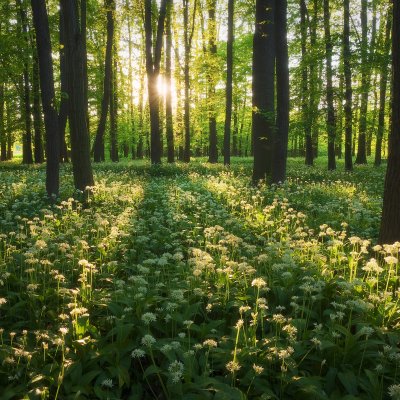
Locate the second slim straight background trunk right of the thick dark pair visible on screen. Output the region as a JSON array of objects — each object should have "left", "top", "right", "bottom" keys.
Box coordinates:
[{"left": 324, "top": 0, "right": 336, "bottom": 170}]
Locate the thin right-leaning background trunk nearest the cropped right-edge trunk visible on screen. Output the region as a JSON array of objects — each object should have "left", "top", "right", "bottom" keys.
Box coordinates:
[{"left": 375, "top": 11, "right": 392, "bottom": 166}]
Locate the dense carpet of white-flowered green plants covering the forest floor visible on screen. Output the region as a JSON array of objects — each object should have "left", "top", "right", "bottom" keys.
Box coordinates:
[{"left": 0, "top": 161, "right": 400, "bottom": 400}]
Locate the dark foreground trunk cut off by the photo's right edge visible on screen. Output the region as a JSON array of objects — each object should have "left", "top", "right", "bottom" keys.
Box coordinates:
[{"left": 379, "top": 0, "right": 400, "bottom": 243}]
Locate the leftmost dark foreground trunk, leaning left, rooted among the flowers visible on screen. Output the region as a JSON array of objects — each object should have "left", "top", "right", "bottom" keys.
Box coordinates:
[{"left": 31, "top": 0, "right": 60, "bottom": 196}]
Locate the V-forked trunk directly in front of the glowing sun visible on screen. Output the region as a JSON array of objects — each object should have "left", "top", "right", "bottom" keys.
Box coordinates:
[{"left": 144, "top": 0, "right": 167, "bottom": 164}]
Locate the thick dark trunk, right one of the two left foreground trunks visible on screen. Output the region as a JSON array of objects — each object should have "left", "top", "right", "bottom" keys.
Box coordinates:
[{"left": 61, "top": 0, "right": 94, "bottom": 191}]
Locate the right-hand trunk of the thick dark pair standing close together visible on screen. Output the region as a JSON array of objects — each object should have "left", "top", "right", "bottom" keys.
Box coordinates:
[{"left": 272, "top": 0, "right": 289, "bottom": 183}]
